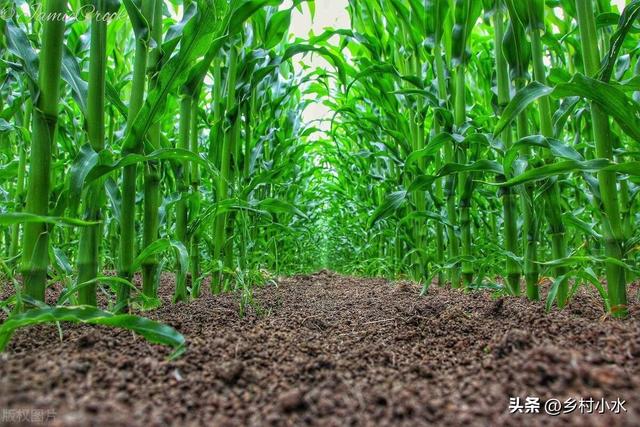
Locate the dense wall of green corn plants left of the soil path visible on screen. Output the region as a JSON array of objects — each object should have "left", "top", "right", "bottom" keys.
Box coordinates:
[{"left": 1, "top": 0, "right": 312, "bottom": 348}]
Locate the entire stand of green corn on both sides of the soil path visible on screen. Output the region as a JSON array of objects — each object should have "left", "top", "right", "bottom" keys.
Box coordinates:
[{"left": 0, "top": 0, "right": 640, "bottom": 424}]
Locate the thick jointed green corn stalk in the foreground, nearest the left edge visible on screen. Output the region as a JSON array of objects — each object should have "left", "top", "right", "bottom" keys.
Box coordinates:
[{"left": 22, "top": 0, "right": 67, "bottom": 301}]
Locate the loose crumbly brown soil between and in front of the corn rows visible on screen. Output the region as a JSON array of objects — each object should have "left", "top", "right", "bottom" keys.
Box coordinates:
[{"left": 0, "top": 272, "right": 640, "bottom": 426}]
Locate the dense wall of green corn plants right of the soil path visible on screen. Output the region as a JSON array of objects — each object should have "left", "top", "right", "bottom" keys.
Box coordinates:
[{"left": 314, "top": 0, "right": 640, "bottom": 316}]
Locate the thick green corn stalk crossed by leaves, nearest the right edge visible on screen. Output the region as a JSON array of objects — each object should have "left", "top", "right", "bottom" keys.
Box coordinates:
[{"left": 576, "top": 0, "right": 628, "bottom": 317}]
